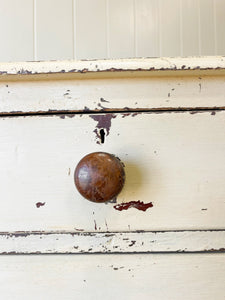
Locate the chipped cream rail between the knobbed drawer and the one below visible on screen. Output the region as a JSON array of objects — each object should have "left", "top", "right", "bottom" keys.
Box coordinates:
[{"left": 0, "top": 231, "right": 225, "bottom": 254}]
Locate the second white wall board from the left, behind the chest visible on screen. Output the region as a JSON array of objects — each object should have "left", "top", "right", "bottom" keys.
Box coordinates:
[{"left": 35, "top": 0, "right": 74, "bottom": 60}]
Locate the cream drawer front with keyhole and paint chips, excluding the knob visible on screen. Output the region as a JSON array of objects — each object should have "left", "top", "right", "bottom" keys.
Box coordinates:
[{"left": 0, "top": 111, "right": 225, "bottom": 231}]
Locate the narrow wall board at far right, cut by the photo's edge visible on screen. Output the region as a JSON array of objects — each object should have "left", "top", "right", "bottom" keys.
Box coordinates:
[{"left": 215, "top": 0, "right": 225, "bottom": 55}]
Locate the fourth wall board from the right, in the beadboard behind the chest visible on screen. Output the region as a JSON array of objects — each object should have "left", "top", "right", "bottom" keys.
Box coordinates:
[{"left": 159, "top": 0, "right": 181, "bottom": 56}]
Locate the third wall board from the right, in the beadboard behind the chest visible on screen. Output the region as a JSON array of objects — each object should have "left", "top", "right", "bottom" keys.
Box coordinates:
[{"left": 180, "top": 0, "right": 200, "bottom": 56}]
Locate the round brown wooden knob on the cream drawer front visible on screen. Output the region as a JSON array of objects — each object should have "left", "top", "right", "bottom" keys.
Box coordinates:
[{"left": 74, "top": 152, "right": 125, "bottom": 202}]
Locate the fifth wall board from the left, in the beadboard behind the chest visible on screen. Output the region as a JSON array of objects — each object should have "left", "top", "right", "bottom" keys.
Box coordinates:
[{"left": 135, "top": 0, "right": 159, "bottom": 57}]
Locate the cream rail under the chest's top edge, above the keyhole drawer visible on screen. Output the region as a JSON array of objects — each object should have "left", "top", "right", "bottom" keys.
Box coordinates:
[{"left": 0, "top": 71, "right": 225, "bottom": 114}]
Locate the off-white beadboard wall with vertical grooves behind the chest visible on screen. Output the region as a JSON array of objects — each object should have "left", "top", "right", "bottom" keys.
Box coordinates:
[{"left": 0, "top": 0, "right": 225, "bottom": 62}]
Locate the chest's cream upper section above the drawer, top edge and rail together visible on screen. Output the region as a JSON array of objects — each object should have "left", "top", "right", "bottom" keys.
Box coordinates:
[{"left": 0, "top": 57, "right": 225, "bottom": 113}]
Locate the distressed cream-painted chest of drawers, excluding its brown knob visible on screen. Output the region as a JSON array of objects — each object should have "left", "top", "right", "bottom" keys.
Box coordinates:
[{"left": 0, "top": 57, "right": 225, "bottom": 299}]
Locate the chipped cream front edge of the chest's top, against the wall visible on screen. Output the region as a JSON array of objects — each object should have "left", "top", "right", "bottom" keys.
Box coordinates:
[{"left": 0, "top": 56, "right": 225, "bottom": 77}]
